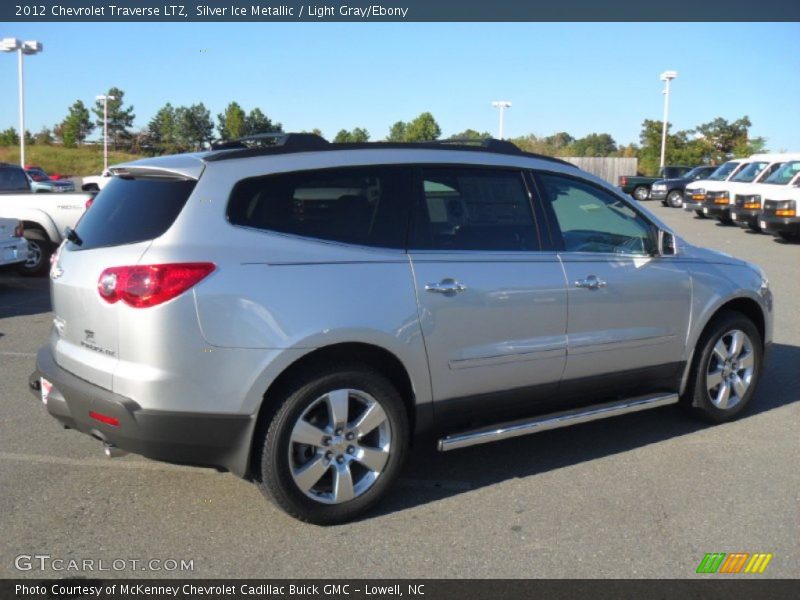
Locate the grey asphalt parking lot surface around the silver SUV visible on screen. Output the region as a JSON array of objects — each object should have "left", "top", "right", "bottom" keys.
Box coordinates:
[{"left": 0, "top": 203, "right": 800, "bottom": 578}]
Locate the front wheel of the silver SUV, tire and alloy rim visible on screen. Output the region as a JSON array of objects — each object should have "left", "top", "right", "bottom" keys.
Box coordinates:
[{"left": 682, "top": 311, "right": 764, "bottom": 423}]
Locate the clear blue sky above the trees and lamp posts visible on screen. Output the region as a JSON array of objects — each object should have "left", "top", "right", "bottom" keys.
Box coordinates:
[{"left": 0, "top": 23, "right": 800, "bottom": 151}]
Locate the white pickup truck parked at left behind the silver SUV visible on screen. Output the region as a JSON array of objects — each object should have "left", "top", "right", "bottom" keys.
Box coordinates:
[{"left": 0, "top": 163, "right": 95, "bottom": 275}]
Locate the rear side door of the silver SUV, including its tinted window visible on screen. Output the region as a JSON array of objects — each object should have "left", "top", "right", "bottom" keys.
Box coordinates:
[{"left": 409, "top": 167, "right": 567, "bottom": 421}]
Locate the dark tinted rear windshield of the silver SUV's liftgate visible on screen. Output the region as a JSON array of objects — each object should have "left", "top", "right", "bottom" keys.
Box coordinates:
[{"left": 70, "top": 177, "right": 197, "bottom": 250}]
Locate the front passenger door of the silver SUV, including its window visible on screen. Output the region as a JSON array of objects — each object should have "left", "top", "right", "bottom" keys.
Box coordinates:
[{"left": 536, "top": 173, "right": 691, "bottom": 397}]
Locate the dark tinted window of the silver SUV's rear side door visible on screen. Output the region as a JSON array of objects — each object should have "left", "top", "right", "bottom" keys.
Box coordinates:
[{"left": 412, "top": 167, "right": 541, "bottom": 251}]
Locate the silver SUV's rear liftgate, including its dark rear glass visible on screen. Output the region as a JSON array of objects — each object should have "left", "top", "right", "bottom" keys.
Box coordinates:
[{"left": 50, "top": 177, "right": 195, "bottom": 389}]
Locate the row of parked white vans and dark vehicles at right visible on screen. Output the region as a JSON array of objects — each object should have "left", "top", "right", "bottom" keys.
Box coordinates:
[{"left": 620, "top": 152, "right": 800, "bottom": 241}]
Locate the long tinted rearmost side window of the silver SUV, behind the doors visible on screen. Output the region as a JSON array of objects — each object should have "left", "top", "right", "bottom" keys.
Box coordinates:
[{"left": 228, "top": 167, "right": 411, "bottom": 248}]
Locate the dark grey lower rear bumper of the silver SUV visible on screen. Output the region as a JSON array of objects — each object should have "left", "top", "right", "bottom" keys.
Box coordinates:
[{"left": 29, "top": 345, "right": 255, "bottom": 477}]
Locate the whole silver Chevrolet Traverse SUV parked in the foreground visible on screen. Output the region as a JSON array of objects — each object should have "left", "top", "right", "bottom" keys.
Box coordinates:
[{"left": 30, "top": 134, "right": 773, "bottom": 524}]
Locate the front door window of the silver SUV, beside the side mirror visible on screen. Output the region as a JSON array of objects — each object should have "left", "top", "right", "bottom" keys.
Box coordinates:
[{"left": 539, "top": 175, "right": 655, "bottom": 255}]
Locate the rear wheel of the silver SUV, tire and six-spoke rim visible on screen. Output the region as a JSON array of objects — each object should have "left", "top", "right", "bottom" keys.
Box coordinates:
[{"left": 259, "top": 365, "right": 409, "bottom": 525}]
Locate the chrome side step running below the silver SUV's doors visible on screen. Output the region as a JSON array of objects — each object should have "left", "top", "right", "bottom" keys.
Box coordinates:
[{"left": 439, "top": 394, "right": 678, "bottom": 452}]
